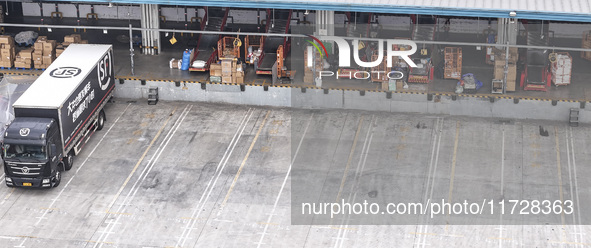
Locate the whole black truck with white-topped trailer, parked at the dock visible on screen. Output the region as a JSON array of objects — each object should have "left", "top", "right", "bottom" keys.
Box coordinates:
[{"left": 2, "top": 44, "right": 115, "bottom": 188}]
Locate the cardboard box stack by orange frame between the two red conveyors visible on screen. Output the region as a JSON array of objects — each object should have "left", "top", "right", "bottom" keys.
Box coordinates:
[{"left": 209, "top": 58, "right": 244, "bottom": 84}]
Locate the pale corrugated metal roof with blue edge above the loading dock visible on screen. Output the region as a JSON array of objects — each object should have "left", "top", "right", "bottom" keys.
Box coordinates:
[{"left": 57, "top": 0, "right": 591, "bottom": 22}]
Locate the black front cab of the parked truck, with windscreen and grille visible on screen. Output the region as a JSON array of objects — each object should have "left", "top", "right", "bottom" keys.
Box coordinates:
[{"left": 2, "top": 117, "right": 65, "bottom": 188}]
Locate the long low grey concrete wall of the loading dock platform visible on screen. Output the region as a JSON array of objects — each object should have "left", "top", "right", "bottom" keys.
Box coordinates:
[{"left": 115, "top": 80, "right": 591, "bottom": 123}]
